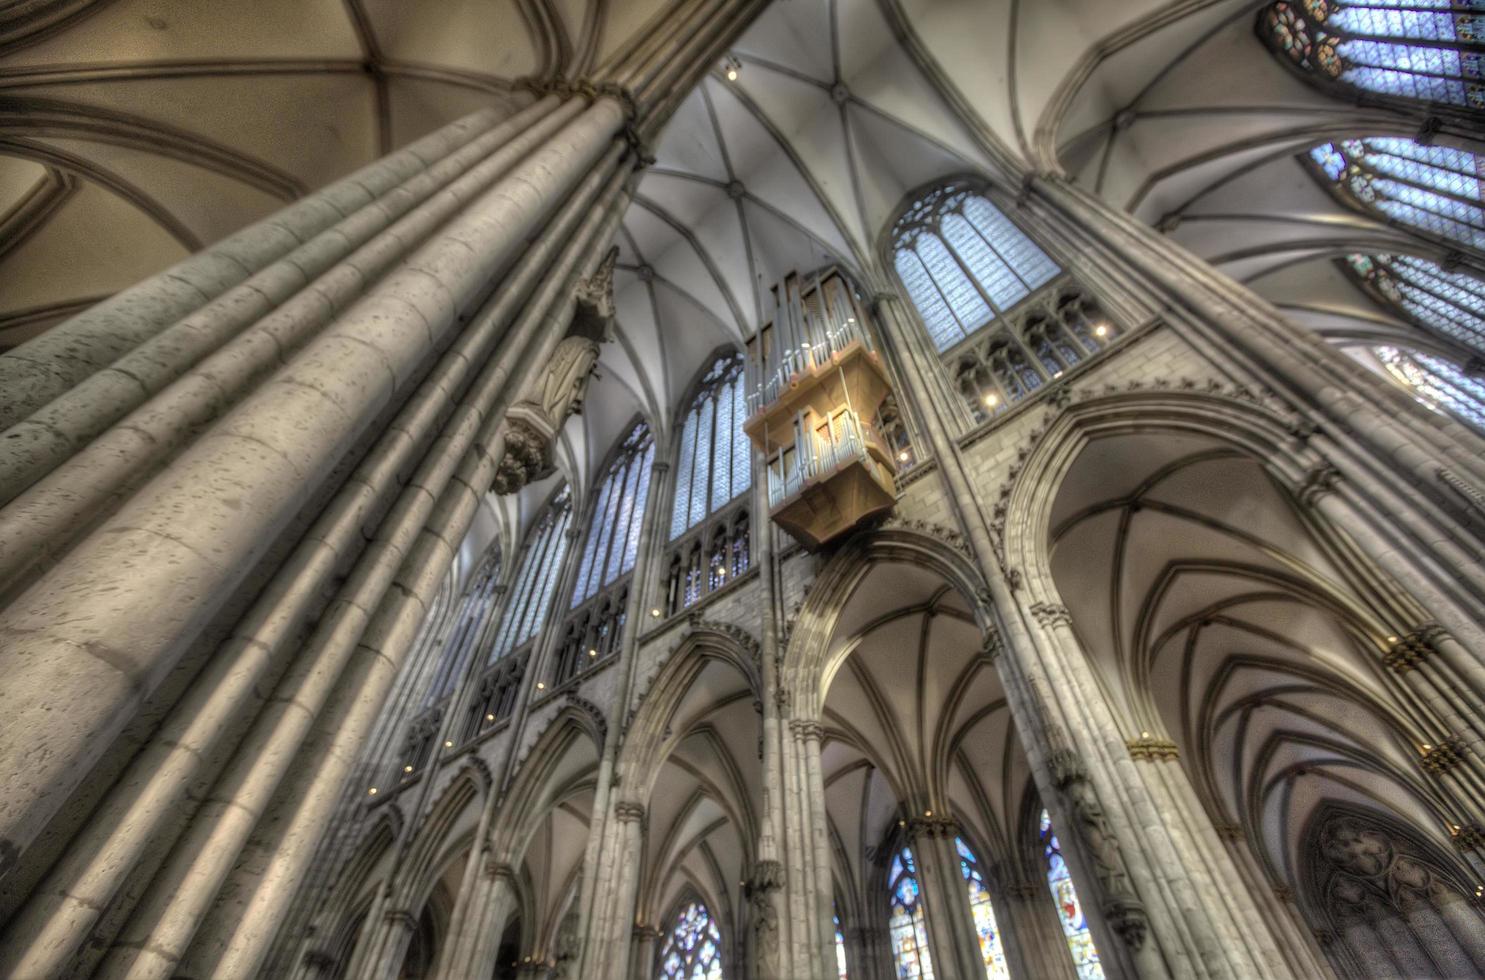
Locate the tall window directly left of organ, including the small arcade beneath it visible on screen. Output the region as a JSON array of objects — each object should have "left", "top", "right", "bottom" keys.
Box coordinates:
[{"left": 664, "top": 353, "right": 753, "bottom": 613}]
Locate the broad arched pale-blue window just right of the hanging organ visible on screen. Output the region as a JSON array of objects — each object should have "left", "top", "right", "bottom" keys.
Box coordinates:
[{"left": 892, "top": 183, "right": 1062, "bottom": 350}]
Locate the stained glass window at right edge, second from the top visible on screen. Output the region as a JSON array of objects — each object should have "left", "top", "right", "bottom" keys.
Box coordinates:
[{"left": 1310, "top": 137, "right": 1485, "bottom": 248}]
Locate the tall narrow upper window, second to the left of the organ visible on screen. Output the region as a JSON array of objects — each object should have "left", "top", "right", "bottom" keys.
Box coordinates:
[{"left": 572, "top": 422, "right": 655, "bottom": 606}]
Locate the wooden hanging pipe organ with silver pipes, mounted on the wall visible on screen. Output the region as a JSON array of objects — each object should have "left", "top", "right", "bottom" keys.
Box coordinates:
[{"left": 744, "top": 269, "right": 898, "bottom": 548}]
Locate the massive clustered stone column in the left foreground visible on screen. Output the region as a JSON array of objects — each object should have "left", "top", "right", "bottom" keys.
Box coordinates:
[{"left": 0, "top": 0, "right": 784, "bottom": 977}]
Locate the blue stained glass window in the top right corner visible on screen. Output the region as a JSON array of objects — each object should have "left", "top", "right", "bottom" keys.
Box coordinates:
[{"left": 1262, "top": 0, "right": 1485, "bottom": 108}]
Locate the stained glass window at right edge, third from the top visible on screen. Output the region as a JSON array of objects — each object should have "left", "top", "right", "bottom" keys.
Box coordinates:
[{"left": 1345, "top": 255, "right": 1485, "bottom": 353}]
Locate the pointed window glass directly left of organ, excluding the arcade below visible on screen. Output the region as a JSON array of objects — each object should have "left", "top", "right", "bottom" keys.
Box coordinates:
[{"left": 670, "top": 353, "right": 753, "bottom": 539}]
